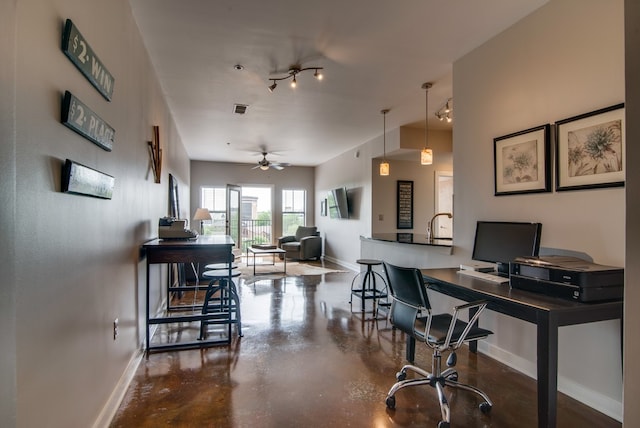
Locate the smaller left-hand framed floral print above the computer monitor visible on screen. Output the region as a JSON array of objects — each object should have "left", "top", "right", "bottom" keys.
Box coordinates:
[{"left": 493, "top": 124, "right": 551, "bottom": 196}]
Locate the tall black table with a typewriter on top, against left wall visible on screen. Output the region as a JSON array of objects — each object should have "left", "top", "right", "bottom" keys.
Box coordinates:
[{"left": 142, "top": 236, "right": 234, "bottom": 353}]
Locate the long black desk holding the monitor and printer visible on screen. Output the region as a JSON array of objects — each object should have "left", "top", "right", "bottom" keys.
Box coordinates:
[{"left": 418, "top": 268, "right": 623, "bottom": 427}]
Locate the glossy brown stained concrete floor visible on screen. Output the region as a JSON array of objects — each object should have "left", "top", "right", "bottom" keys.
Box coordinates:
[{"left": 111, "top": 264, "right": 621, "bottom": 428}]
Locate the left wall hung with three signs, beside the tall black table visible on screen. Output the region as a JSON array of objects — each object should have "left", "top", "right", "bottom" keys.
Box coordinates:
[{"left": 5, "top": 0, "right": 189, "bottom": 427}]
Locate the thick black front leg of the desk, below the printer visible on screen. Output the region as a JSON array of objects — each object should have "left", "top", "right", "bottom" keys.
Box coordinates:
[{"left": 537, "top": 313, "right": 558, "bottom": 428}]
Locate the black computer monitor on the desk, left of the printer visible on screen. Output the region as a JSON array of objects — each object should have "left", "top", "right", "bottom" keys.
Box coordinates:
[{"left": 472, "top": 221, "right": 542, "bottom": 276}]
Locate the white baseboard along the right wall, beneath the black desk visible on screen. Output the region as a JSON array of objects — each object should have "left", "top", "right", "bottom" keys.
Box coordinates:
[{"left": 478, "top": 341, "right": 622, "bottom": 422}]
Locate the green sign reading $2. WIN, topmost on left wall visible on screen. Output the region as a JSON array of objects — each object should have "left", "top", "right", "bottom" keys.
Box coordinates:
[{"left": 62, "top": 19, "right": 115, "bottom": 101}]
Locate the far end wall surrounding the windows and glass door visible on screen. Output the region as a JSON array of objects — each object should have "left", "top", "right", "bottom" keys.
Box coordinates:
[{"left": 188, "top": 161, "right": 322, "bottom": 241}]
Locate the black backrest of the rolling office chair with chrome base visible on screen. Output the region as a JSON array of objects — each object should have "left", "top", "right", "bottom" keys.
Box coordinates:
[{"left": 382, "top": 262, "right": 431, "bottom": 335}]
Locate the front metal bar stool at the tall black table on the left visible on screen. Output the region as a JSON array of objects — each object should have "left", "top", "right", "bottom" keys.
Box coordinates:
[{"left": 199, "top": 264, "right": 242, "bottom": 343}]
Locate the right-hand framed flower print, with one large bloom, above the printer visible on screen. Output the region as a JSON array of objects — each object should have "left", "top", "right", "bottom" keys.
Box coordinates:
[{"left": 556, "top": 104, "right": 626, "bottom": 191}]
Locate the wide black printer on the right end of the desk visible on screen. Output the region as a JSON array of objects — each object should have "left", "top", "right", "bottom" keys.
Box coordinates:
[{"left": 509, "top": 255, "right": 624, "bottom": 302}]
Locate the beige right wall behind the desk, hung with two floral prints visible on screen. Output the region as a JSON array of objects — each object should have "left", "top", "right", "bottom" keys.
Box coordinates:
[{"left": 453, "top": 0, "right": 629, "bottom": 418}]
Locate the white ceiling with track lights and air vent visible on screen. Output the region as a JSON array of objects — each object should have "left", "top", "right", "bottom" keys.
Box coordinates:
[{"left": 130, "top": 0, "right": 547, "bottom": 166}]
